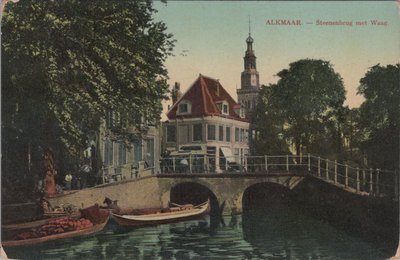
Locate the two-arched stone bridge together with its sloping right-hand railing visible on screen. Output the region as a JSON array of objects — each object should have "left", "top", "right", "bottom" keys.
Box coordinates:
[{"left": 49, "top": 156, "right": 397, "bottom": 213}]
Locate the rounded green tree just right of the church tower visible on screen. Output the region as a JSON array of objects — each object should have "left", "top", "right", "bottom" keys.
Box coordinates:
[{"left": 256, "top": 59, "right": 345, "bottom": 155}]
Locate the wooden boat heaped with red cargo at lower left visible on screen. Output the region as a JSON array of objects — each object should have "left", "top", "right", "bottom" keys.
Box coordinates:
[{"left": 2, "top": 204, "right": 110, "bottom": 247}]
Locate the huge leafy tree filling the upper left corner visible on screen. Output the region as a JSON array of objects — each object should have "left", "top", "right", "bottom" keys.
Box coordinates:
[{"left": 2, "top": 0, "right": 174, "bottom": 198}]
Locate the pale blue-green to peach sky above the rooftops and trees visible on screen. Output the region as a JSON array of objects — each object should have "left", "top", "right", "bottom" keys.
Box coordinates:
[{"left": 154, "top": 1, "right": 400, "bottom": 112}]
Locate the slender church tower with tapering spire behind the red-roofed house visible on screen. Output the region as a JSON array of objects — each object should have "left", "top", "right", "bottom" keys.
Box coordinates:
[{"left": 237, "top": 23, "right": 260, "bottom": 118}]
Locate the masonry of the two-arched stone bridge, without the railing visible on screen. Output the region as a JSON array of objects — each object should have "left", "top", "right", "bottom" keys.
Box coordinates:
[{"left": 49, "top": 172, "right": 305, "bottom": 213}]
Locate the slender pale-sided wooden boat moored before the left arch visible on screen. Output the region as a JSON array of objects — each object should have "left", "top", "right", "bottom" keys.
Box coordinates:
[{"left": 111, "top": 200, "right": 210, "bottom": 227}]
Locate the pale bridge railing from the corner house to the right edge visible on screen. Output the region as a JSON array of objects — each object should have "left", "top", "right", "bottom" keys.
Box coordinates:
[{"left": 160, "top": 155, "right": 398, "bottom": 197}]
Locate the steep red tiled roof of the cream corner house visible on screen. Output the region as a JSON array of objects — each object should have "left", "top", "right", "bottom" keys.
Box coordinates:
[{"left": 167, "top": 74, "right": 247, "bottom": 121}]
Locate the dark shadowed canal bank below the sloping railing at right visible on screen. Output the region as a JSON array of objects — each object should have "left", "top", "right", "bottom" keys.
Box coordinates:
[{"left": 292, "top": 177, "right": 399, "bottom": 245}]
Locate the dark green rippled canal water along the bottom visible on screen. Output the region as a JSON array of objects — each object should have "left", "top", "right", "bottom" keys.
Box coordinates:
[{"left": 6, "top": 207, "right": 396, "bottom": 260}]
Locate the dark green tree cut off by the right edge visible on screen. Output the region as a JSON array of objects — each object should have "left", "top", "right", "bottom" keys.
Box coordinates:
[{"left": 358, "top": 64, "right": 400, "bottom": 169}]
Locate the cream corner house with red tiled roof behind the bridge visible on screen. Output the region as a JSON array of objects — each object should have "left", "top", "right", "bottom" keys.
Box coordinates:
[{"left": 163, "top": 74, "right": 249, "bottom": 172}]
